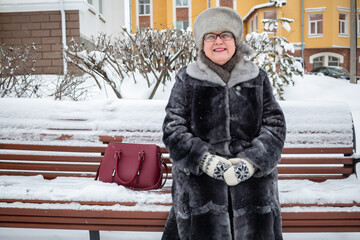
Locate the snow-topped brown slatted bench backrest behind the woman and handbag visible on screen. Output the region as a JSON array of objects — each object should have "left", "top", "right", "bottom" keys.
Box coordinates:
[{"left": 0, "top": 99, "right": 354, "bottom": 181}]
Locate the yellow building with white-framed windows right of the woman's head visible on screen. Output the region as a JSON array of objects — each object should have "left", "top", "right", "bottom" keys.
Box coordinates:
[{"left": 237, "top": 0, "right": 360, "bottom": 72}]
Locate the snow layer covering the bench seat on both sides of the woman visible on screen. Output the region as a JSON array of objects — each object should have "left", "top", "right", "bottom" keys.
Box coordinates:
[{"left": 0, "top": 172, "right": 360, "bottom": 211}]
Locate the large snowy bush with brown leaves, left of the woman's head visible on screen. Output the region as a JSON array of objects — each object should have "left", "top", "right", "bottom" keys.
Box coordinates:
[{"left": 66, "top": 28, "right": 196, "bottom": 99}]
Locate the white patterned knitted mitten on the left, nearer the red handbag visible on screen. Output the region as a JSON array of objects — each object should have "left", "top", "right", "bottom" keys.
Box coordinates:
[{"left": 200, "top": 153, "right": 231, "bottom": 180}]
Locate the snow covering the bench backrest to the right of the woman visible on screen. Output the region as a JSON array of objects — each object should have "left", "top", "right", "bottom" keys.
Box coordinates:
[{"left": 281, "top": 101, "right": 353, "bottom": 147}]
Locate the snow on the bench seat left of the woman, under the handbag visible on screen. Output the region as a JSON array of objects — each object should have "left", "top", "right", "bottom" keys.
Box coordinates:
[{"left": 0, "top": 175, "right": 171, "bottom": 211}]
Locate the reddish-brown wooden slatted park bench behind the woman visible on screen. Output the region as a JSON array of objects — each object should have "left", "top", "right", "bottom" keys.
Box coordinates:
[{"left": 0, "top": 98, "right": 360, "bottom": 239}]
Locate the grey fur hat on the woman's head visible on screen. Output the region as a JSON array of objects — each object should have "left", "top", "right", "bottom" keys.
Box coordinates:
[{"left": 193, "top": 7, "right": 243, "bottom": 50}]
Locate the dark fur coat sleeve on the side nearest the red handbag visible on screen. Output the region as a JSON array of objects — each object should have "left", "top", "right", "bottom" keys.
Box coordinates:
[{"left": 163, "top": 68, "right": 212, "bottom": 175}]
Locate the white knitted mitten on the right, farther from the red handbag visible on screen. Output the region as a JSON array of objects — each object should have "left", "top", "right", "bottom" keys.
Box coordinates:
[{"left": 224, "top": 158, "right": 256, "bottom": 186}]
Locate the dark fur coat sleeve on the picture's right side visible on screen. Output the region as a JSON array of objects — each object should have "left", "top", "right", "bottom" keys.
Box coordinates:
[{"left": 237, "top": 70, "right": 286, "bottom": 177}]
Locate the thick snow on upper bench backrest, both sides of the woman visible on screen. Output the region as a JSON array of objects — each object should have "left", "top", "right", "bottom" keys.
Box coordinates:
[{"left": 0, "top": 98, "right": 353, "bottom": 147}]
